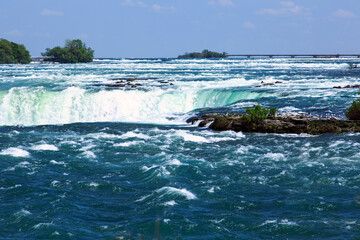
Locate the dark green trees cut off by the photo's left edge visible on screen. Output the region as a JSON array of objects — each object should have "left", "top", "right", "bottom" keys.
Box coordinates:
[{"left": 0, "top": 39, "right": 31, "bottom": 64}]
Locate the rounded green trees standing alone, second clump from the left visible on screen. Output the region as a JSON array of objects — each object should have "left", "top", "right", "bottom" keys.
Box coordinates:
[{"left": 41, "top": 39, "right": 94, "bottom": 63}]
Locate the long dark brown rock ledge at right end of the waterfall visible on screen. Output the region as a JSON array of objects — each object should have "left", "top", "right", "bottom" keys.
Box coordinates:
[{"left": 188, "top": 114, "right": 360, "bottom": 135}]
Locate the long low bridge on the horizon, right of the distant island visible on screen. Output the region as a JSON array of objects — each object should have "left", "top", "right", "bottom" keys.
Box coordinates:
[{"left": 227, "top": 54, "right": 360, "bottom": 58}]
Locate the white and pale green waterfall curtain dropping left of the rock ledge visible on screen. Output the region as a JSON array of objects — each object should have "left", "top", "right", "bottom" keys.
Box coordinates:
[{"left": 0, "top": 87, "right": 265, "bottom": 126}]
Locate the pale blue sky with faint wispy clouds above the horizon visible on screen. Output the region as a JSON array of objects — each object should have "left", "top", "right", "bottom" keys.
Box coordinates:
[{"left": 0, "top": 0, "right": 360, "bottom": 57}]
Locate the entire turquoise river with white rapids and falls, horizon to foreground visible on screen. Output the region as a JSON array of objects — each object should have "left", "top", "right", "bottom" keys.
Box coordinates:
[{"left": 0, "top": 59, "right": 360, "bottom": 239}]
